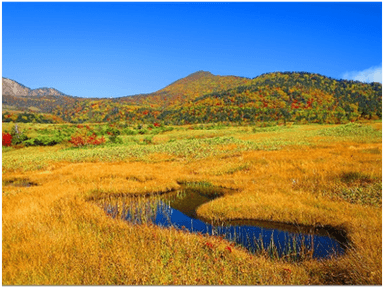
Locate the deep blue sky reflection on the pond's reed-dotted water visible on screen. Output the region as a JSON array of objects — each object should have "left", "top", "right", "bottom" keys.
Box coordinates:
[{"left": 105, "top": 196, "right": 344, "bottom": 258}]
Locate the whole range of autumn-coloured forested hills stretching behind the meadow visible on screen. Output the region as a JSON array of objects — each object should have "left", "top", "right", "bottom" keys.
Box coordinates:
[{"left": 2, "top": 71, "right": 383, "bottom": 124}]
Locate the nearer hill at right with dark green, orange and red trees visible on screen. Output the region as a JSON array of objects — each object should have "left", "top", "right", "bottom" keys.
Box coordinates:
[{"left": 158, "top": 72, "right": 383, "bottom": 123}]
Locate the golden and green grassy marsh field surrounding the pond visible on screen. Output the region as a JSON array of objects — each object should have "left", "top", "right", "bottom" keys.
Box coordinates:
[{"left": 1, "top": 121, "right": 383, "bottom": 285}]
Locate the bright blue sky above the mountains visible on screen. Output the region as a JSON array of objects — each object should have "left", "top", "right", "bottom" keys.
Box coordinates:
[{"left": 1, "top": 1, "right": 383, "bottom": 97}]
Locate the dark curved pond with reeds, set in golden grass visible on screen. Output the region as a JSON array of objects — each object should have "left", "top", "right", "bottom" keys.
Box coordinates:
[{"left": 97, "top": 188, "right": 347, "bottom": 260}]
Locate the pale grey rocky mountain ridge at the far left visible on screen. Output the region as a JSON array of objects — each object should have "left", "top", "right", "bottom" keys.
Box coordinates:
[{"left": 1, "top": 77, "right": 67, "bottom": 97}]
